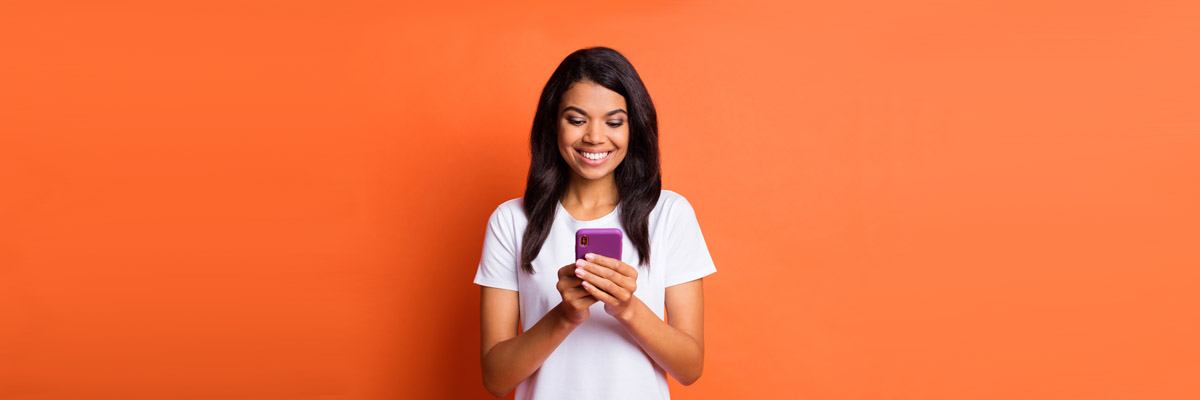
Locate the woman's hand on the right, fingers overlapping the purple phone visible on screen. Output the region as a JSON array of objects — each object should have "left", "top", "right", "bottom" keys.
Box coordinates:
[{"left": 575, "top": 253, "right": 640, "bottom": 321}]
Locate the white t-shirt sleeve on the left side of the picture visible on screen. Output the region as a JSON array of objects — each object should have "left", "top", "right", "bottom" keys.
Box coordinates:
[{"left": 475, "top": 204, "right": 521, "bottom": 291}]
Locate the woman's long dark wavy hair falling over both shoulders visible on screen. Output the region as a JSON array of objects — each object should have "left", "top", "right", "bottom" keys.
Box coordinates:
[{"left": 521, "top": 47, "right": 662, "bottom": 274}]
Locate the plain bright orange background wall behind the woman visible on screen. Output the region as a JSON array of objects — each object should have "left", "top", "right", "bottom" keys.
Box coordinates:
[{"left": 0, "top": 1, "right": 1200, "bottom": 400}]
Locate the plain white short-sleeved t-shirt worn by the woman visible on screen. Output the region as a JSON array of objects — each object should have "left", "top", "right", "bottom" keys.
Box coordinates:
[{"left": 475, "top": 190, "right": 716, "bottom": 399}]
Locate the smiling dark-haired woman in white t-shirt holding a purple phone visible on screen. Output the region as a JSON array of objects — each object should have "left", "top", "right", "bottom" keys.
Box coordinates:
[{"left": 475, "top": 47, "right": 716, "bottom": 399}]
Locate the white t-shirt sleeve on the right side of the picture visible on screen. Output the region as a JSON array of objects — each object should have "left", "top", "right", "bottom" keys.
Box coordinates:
[{"left": 662, "top": 194, "right": 716, "bottom": 287}]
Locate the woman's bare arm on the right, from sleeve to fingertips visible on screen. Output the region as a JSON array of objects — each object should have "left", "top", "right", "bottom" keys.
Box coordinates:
[{"left": 580, "top": 256, "right": 704, "bottom": 386}]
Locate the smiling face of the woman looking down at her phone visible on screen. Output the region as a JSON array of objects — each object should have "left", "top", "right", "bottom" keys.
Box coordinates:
[{"left": 558, "top": 80, "right": 629, "bottom": 179}]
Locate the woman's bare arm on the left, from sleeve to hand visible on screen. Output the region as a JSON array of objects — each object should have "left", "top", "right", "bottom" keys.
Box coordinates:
[{"left": 479, "top": 264, "right": 596, "bottom": 398}]
